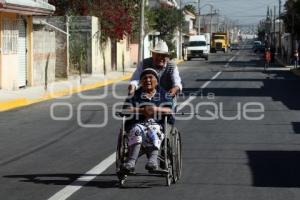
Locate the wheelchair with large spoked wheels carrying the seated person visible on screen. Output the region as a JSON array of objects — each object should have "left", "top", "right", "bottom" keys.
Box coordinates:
[{"left": 116, "top": 112, "right": 182, "bottom": 187}]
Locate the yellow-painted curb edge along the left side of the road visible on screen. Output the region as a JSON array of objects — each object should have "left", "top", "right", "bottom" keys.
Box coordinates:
[{"left": 0, "top": 73, "right": 132, "bottom": 112}]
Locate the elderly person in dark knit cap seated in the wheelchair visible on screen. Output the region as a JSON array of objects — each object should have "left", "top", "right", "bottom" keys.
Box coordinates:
[{"left": 121, "top": 68, "right": 173, "bottom": 173}]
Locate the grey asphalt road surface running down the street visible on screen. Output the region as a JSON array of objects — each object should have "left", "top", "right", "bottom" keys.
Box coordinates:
[{"left": 0, "top": 43, "right": 300, "bottom": 200}]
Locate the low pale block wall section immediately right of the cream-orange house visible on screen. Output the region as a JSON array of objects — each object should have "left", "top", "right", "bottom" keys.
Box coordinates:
[{"left": 33, "top": 30, "right": 56, "bottom": 85}]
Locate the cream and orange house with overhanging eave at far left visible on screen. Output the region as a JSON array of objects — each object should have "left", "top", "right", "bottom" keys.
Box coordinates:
[{"left": 0, "top": 0, "right": 55, "bottom": 90}]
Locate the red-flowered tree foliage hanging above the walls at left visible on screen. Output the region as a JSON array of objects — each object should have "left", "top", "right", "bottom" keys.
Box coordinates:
[{"left": 49, "top": 0, "right": 139, "bottom": 41}]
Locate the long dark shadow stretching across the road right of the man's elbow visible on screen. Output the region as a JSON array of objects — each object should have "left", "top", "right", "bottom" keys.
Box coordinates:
[{"left": 183, "top": 70, "right": 300, "bottom": 110}]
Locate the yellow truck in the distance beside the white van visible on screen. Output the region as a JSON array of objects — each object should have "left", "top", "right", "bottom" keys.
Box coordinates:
[{"left": 210, "top": 32, "right": 229, "bottom": 53}]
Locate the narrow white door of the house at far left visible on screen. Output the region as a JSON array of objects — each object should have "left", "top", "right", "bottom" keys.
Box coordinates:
[{"left": 18, "top": 19, "right": 27, "bottom": 87}]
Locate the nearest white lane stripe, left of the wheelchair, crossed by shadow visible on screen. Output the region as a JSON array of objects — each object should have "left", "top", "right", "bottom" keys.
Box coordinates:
[{"left": 48, "top": 152, "right": 116, "bottom": 200}]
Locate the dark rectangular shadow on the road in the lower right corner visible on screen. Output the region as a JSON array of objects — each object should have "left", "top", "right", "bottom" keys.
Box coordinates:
[{"left": 247, "top": 151, "right": 300, "bottom": 188}]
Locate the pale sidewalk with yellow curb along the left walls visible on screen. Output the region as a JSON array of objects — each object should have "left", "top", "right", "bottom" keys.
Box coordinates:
[{"left": 0, "top": 68, "right": 135, "bottom": 112}]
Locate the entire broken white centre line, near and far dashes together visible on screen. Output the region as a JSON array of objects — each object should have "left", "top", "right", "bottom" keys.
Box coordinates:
[{"left": 48, "top": 53, "right": 234, "bottom": 200}]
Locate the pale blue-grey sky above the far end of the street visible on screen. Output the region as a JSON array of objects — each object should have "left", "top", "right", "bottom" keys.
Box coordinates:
[{"left": 182, "top": 0, "right": 286, "bottom": 25}]
